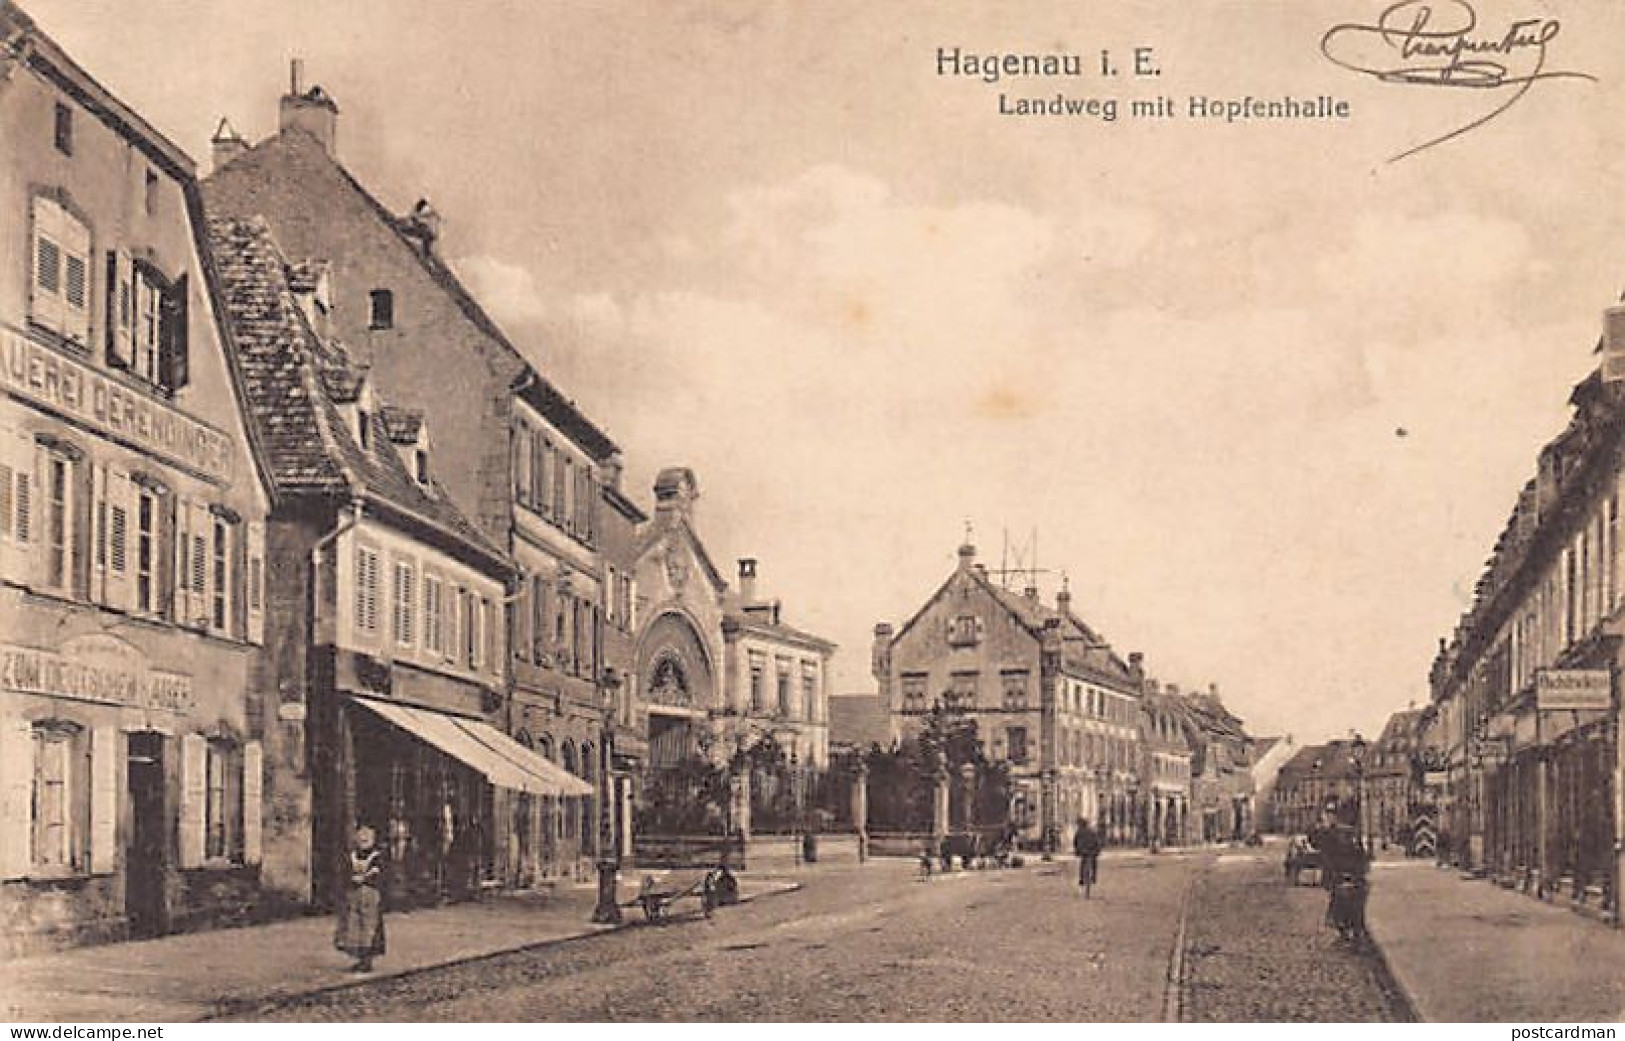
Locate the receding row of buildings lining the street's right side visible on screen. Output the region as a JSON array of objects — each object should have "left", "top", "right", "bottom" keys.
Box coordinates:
[{"left": 1414, "top": 298, "right": 1625, "bottom": 924}]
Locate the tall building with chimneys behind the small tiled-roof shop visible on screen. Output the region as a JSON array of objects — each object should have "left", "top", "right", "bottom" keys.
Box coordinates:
[{"left": 205, "top": 71, "right": 637, "bottom": 875}]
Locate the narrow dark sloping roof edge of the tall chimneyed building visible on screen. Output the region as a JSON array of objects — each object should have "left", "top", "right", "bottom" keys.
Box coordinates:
[{"left": 203, "top": 127, "right": 618, "bottom": 463}]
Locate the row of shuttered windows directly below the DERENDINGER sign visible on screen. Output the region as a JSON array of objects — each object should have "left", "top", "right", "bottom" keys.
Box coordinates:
[{"left": 0, "top": 435, "right": 265, "bottom": 640}]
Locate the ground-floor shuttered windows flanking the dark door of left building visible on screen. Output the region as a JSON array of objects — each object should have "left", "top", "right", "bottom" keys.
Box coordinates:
[{"left": 0, "top": 718, "right": 263, "bottom": 879}]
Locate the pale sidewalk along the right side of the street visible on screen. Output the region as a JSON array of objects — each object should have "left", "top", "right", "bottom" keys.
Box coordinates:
[{"left": 1367, "top": 861, "right": 1625, "bottom": 1023}]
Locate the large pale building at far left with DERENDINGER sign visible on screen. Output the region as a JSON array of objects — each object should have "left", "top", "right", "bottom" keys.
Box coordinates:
[{"left": 0, "top": 3, "right": 275, "bottom": 955}]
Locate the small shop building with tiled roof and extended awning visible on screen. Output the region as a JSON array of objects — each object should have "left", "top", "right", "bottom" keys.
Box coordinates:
[{"left": 210, "top": 218, "right": 592, "bottom": 908}]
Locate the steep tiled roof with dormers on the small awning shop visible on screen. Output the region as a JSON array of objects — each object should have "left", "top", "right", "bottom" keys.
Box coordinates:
[{"left": 208, "top": 218, "right": 510, "bottom": 572}]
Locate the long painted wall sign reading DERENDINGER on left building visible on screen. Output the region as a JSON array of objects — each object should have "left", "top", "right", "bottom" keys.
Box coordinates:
[{"left": 0, "top": 330, "right": 232, "bottom": 481}]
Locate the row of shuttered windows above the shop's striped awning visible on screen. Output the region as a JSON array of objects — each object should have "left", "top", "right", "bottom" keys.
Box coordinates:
[{"left": 353, "top": 544, "right": 501, "bottom": 671}]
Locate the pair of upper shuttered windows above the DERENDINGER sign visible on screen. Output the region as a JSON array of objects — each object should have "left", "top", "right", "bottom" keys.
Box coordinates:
[{"left": 28, "top": 195, "right": 190, "bottom": 391}]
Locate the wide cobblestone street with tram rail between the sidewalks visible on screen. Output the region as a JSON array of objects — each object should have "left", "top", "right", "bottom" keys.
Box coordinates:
[{"left": 222, "top": 853, "right": 1406, "bottom": 1022}]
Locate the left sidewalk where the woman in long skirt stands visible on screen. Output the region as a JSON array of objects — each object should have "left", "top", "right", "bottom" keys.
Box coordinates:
[{"left": 0, "top": 867, "right": 812, "bottom": 1023}]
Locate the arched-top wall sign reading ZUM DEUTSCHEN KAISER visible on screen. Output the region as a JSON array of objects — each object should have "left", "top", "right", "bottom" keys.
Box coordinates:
[{"left": 0, "top": 635, "right": 193, "bottom": 715}]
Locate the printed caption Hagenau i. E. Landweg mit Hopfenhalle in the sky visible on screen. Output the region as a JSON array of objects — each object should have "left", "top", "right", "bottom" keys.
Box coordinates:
[{"left": 934, "top": 45, "right": 1350, "bottom": 123}]
